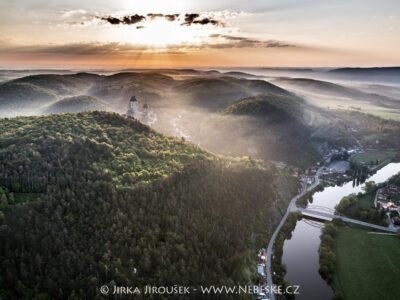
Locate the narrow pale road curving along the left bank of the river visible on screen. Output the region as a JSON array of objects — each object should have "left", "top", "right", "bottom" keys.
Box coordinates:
[{"left": 265, "top": 167, "right": 322, "bottom": 300}]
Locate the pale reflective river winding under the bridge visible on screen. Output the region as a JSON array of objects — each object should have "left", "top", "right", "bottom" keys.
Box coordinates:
[{"left": 282, "top": 163, "right": 400, "bottom": 300}]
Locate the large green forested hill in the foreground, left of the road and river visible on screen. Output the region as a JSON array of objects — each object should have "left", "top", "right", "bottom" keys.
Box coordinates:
[{"left": 0, "top": 112, "right": 296, "bottom": 299}]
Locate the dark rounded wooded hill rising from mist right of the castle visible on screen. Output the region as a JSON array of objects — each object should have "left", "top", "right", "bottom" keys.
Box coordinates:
[{"left": 219, "top": 94, "right": 319, "bottom": 166}]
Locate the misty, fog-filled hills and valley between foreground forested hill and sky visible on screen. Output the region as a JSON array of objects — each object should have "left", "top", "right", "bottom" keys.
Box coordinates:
[{"left": 0, "top": 69, "right": 400, "bottom": 166}]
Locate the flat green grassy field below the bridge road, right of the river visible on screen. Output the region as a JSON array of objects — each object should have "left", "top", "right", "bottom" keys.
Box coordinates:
[{"left": 334, "top": 227, "right": 400, "bottom": 300}]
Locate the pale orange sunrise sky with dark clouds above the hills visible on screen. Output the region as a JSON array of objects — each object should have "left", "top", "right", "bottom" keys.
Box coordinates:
[{"left": 0, "top": 0, "right": 400, "bottom": 69}]
